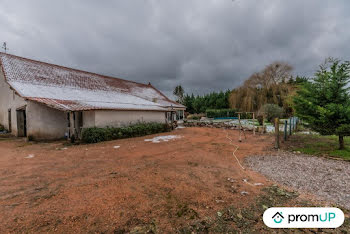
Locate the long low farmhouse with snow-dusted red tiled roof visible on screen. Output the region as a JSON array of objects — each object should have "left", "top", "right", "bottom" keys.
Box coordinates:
[{"left": 0, "top": 53, "right": 185, "bottom": 139}]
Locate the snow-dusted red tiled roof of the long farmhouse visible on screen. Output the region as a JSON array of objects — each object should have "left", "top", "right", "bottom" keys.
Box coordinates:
[{"left": 0, "top": 53, "right": 185, "bottom": 111}]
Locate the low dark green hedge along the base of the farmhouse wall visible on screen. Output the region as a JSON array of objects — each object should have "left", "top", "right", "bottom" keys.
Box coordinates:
[{"left": 82, "top": 123, "right": 170, "bottom": 144}]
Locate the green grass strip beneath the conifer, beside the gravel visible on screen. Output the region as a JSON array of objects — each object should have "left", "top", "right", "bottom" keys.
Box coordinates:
[{"left": 286, "top": 134, "right": 350, "bottom": 161}]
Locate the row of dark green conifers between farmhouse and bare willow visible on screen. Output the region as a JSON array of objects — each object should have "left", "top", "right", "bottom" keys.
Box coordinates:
[{"left": 184, "top": 91, "right": 230, "bottom": 114}]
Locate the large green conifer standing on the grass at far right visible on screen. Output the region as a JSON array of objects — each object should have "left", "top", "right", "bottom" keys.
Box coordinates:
[{"left": 294, "top": 58, "right": 350, "bottom": 149}]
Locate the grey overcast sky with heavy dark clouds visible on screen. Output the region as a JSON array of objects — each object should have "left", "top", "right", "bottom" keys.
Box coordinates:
[{"left": 0, "top": 0, "right": 350, "bottom": 95}]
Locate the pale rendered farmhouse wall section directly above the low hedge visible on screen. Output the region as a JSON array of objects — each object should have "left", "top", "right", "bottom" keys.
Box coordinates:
[{"left": 93, "top": 110, "right": 166, "bottom": 127}]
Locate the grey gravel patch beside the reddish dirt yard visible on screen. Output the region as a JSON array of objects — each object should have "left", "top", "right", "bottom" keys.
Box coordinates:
[{"left": 246, "top": 152, "right": 350, "bottom": 209}]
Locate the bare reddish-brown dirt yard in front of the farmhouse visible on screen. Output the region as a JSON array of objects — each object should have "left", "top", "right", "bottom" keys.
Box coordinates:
[{"left": 0, "top": 128, "right": 273, "bottom": 233}]
